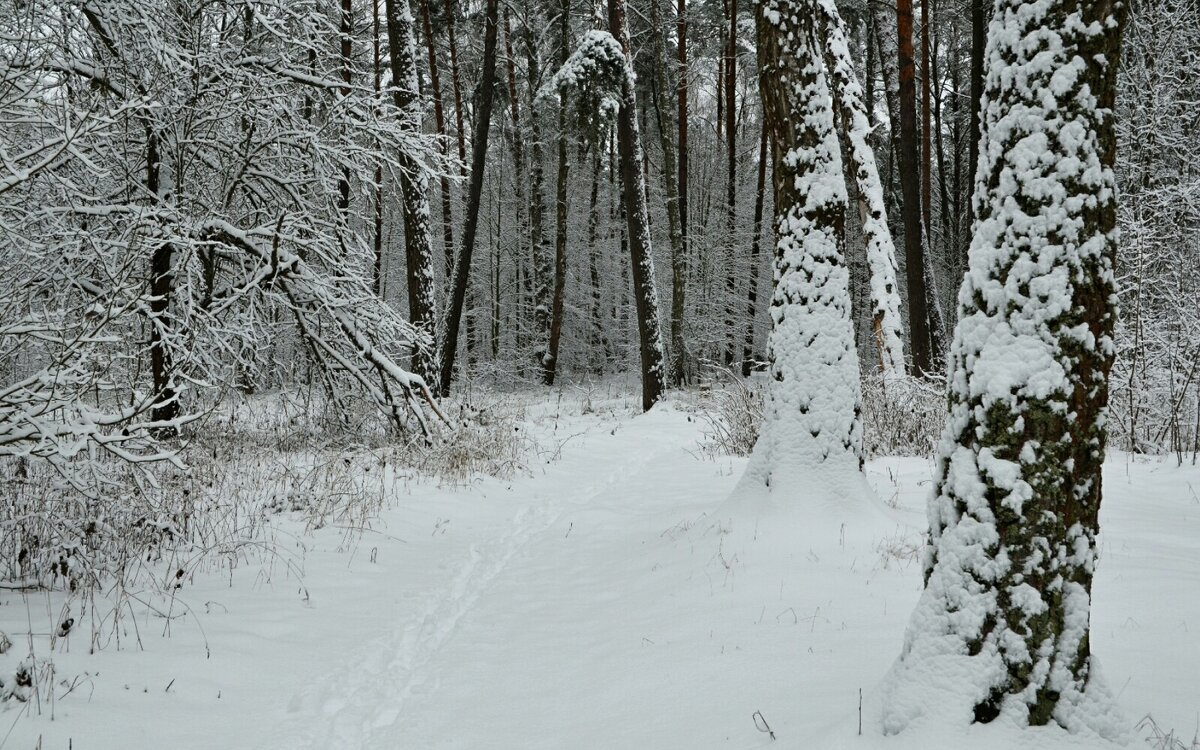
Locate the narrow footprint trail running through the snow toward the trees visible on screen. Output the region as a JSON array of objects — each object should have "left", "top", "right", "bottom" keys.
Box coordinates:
[{"left": 265, "top": 410, "right": 695, "bottom": 750}]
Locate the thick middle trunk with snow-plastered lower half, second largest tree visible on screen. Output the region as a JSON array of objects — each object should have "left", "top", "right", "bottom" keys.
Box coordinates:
[{"left": 748, "top": 0, "right": 863, "bottom": 487}]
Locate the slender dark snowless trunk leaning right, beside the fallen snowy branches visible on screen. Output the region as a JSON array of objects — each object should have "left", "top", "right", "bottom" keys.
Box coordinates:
[{"left": 442, "top": 0, "right": 499, "bottom": 392}]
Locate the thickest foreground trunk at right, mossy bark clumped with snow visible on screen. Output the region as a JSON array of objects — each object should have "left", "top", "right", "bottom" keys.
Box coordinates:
[{"left": 883, "top": 0, "right": 1126, "bottom": 736}]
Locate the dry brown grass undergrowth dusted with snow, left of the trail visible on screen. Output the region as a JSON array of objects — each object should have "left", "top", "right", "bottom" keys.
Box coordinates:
[{"left": 0, "top": 392, "right": 549, "bottom": 715}]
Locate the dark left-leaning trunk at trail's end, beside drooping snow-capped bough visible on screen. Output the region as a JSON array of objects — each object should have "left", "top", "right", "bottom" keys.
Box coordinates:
[{"left": 608, "top": 0, "right": 665, "bottom": 410}]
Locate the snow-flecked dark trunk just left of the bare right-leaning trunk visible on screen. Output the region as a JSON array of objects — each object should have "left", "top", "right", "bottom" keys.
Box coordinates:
[{"left": 384, "top": 0, "right": 438, "bottom": 388}]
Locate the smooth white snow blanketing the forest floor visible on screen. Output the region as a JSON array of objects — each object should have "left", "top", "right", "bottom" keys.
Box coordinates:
[{"left": 0, "top": 402, "right": 1200, "bottom": 750}]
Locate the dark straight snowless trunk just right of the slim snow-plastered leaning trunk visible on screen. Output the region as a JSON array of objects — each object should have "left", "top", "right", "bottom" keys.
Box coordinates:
[{"left": 896, "top": 0, "right": 932, "bottom": 374}]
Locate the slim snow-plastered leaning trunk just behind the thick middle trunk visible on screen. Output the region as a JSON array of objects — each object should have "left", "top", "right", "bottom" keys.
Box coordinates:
[{"left": 818, "top": 0, "right": 905, "bottom": 376}]
